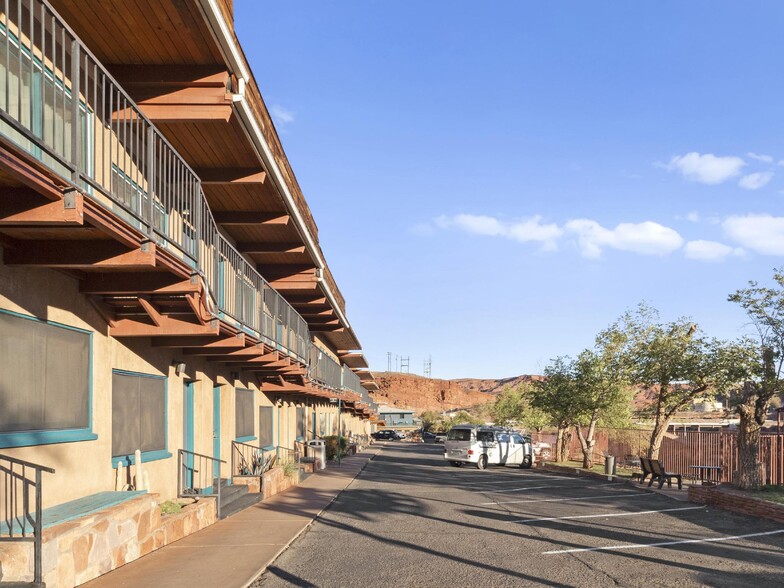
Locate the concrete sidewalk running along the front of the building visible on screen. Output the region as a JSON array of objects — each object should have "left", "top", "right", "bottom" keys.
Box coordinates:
[{"left": 83, "top": 448, "right": 380, "bottom": 588}]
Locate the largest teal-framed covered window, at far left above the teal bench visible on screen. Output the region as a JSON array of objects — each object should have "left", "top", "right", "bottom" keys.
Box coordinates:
[{"left": 0, "top": 313, "right": 90, "bottom": 432}]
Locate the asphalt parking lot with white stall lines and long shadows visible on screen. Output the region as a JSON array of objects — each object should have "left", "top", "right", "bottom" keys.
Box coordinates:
[{"left": 254, "top": 443, "right": 784, "bottom": 588}]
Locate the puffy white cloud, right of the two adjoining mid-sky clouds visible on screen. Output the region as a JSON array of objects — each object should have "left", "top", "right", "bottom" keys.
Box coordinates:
[{"left": 565, "top": 219, "right": 683, "bottom": 259}]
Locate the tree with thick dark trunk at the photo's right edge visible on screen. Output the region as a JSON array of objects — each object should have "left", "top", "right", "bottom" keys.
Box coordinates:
[{"left": 729, "top": 268, "right": 784, "bottom": 489}]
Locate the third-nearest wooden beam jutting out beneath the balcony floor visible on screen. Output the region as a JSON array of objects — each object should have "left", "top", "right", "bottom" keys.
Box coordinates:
[{"left": 79, "top": 272, "right": 201, "bottom": 296}]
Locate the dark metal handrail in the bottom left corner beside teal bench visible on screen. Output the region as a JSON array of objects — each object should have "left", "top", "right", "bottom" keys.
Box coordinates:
[{"left": 0, "top": 454, "right": 54, "bottom": 583}]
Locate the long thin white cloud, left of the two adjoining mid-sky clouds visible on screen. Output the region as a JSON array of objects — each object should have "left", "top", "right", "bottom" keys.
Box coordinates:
[{"left": 435, "top": 214, "right": 563, "bottom": 249}]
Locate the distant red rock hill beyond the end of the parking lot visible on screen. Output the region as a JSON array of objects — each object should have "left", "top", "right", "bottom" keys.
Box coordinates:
[{"left": 373, "top": 372, "right": 541, "bottom": 413}]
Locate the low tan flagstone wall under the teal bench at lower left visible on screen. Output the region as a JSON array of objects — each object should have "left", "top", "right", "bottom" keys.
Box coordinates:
[{"left": 0, "top": 494, "right": 215, "bottom": 587}]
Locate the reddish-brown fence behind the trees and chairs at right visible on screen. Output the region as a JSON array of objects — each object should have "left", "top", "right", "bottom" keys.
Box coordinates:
[{"left": 569, "top": 429, "right": 784, "bottom": 484}]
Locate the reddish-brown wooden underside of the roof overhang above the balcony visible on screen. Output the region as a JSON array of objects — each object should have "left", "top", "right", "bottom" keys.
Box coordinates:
[{"left": 52, "top": 0, "right": 359, "bottom": 349}]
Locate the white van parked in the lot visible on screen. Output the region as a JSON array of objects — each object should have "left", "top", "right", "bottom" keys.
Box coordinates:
[{"left": 444, "top": 425, "right": 534, "bottom": 470}]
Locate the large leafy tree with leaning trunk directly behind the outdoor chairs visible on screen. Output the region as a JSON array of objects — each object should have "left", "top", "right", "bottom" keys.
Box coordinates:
[{"left": 612, "top": 304, "right": 723, "bottom": 459}]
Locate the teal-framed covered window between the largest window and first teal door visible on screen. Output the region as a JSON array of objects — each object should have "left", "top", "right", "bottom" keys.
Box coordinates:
[{"left": 112, "top": 372, "right": 166, "bottom": 457}]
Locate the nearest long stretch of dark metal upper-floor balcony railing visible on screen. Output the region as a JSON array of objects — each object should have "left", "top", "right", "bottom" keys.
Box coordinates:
[{"left": 0, "top": 0, "right": 310, "bottom": 363}]
